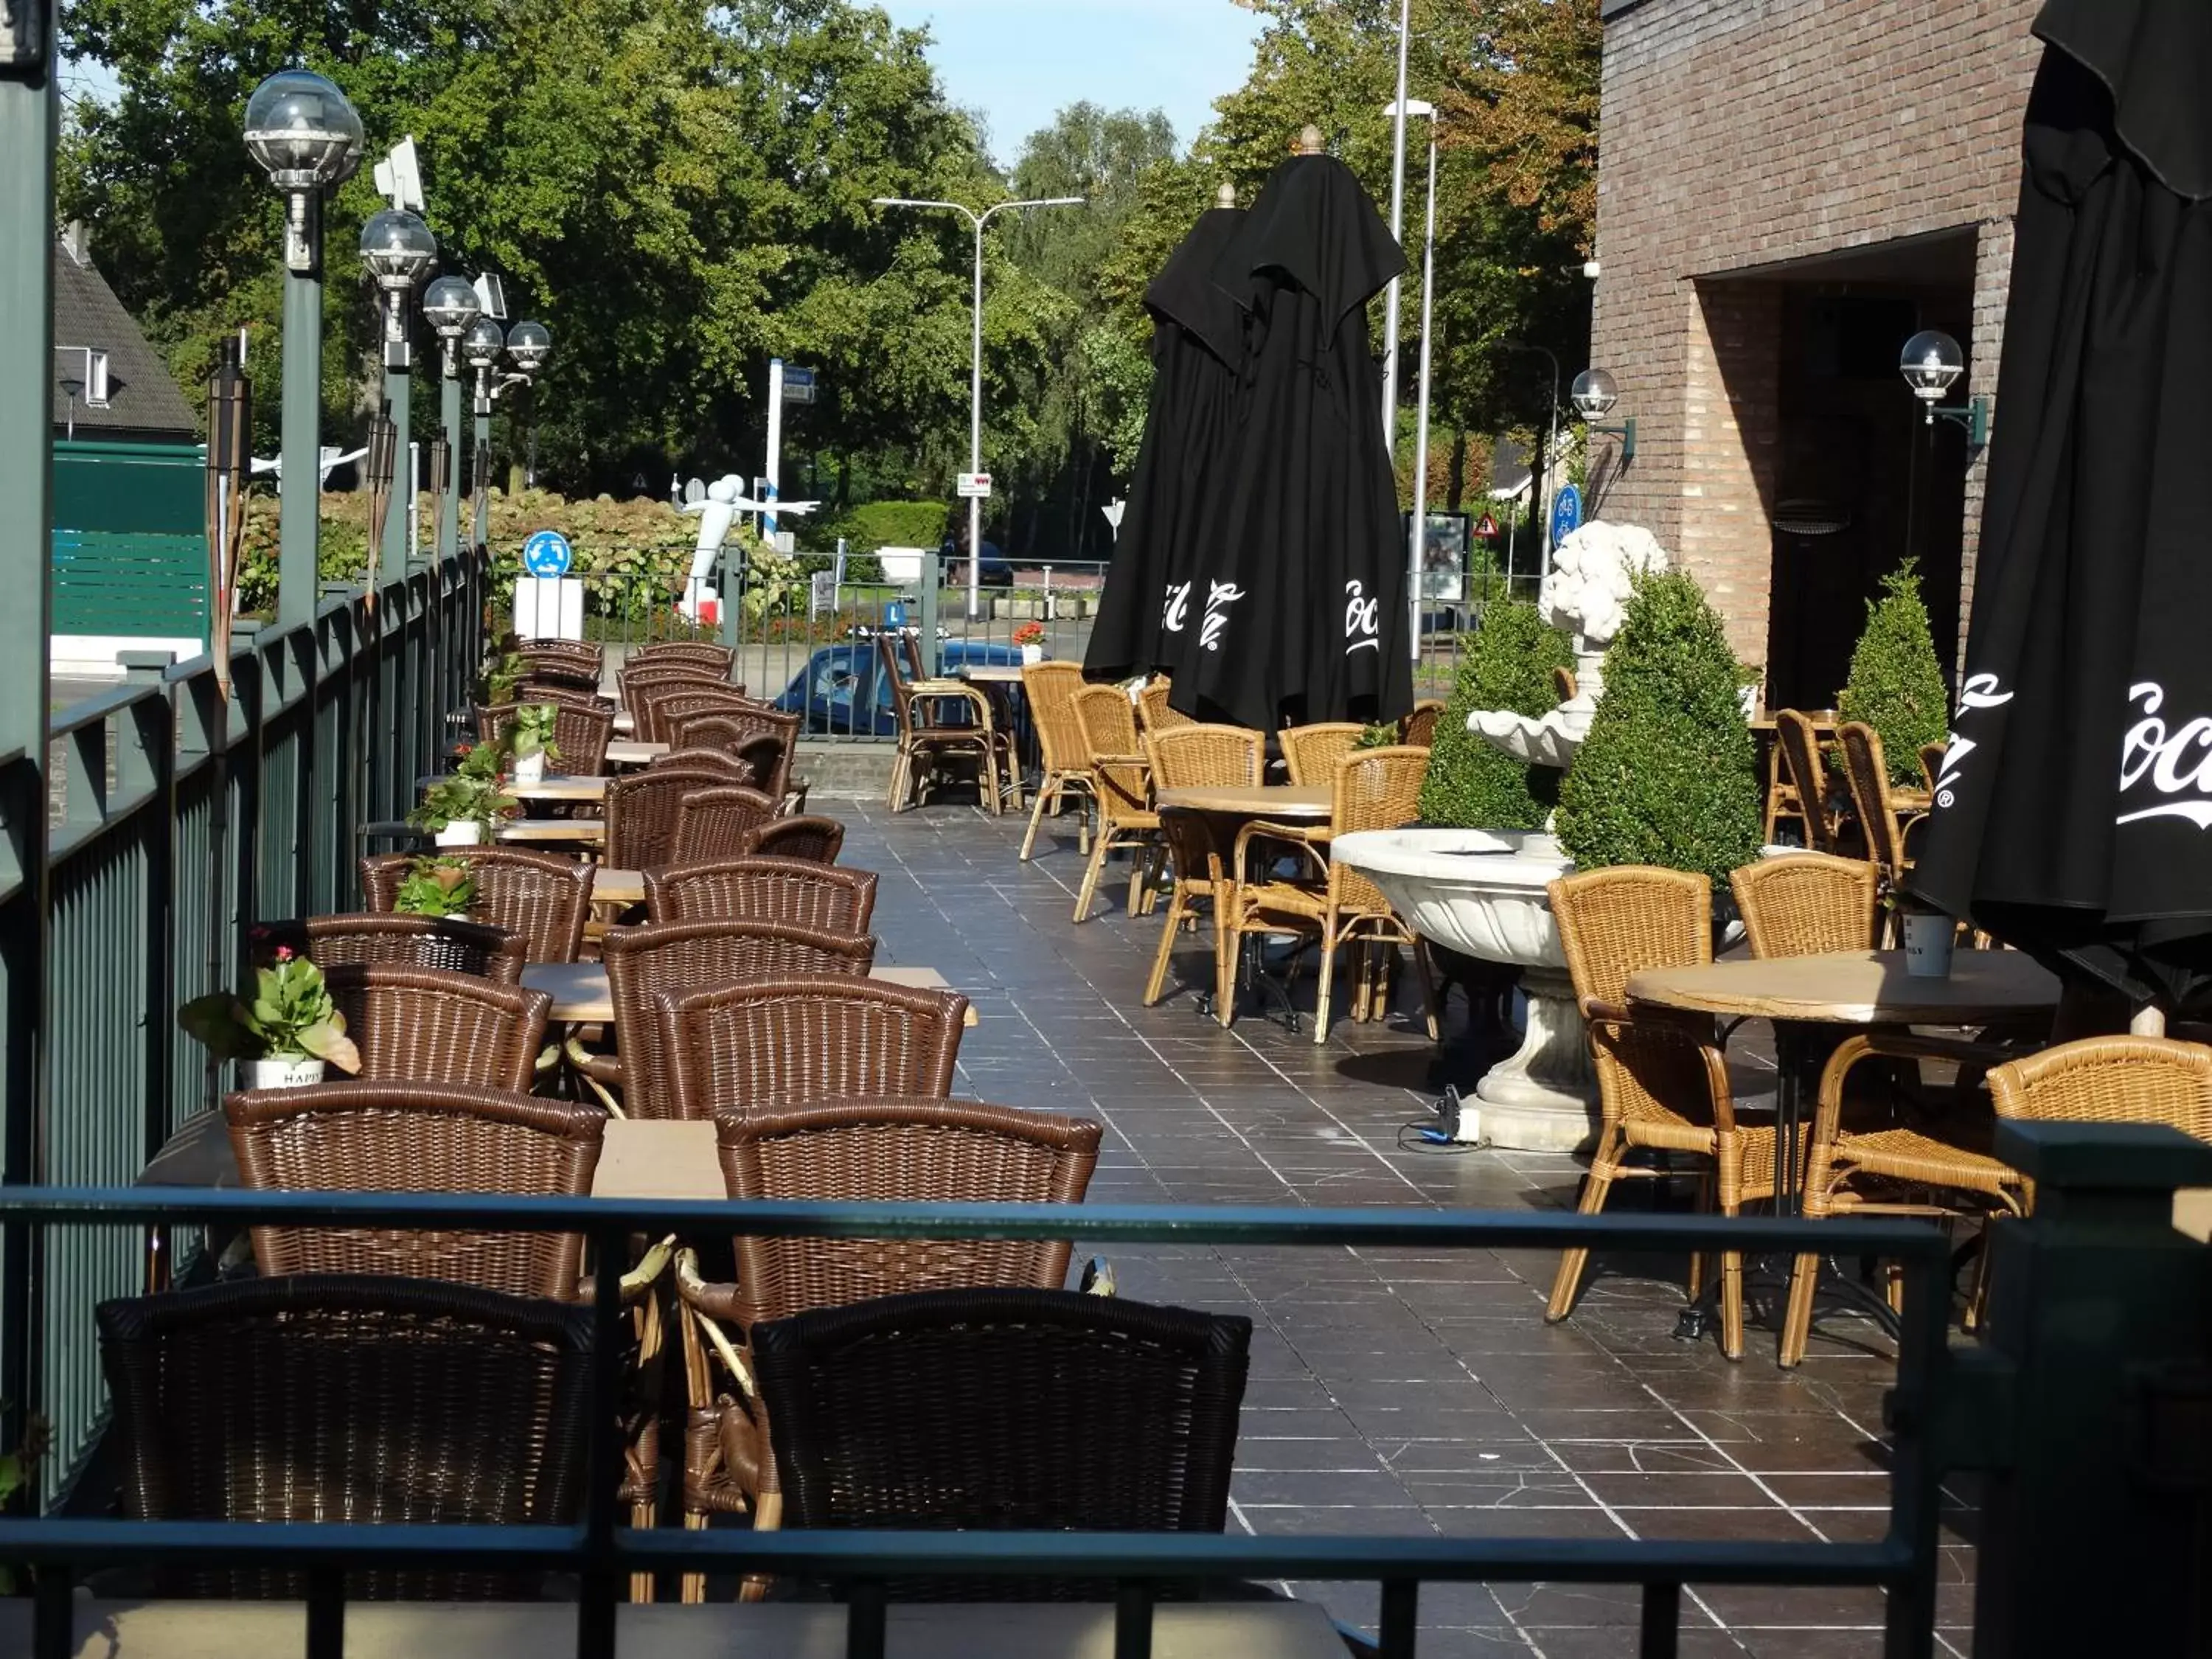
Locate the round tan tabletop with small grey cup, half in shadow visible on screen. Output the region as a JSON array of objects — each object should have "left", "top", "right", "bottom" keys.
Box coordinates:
[{"left": 1628, "top": 951, "right": 2059, "bottom": 1026}]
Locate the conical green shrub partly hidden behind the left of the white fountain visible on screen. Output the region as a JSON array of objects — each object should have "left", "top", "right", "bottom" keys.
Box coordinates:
[{"left": 1420, "top": 599, "right": 1575, "bottom": 830}]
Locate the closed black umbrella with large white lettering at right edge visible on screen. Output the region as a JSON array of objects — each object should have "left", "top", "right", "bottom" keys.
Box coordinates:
[{"left": 1911, "top": 0, "right": 2212, "bottom": 1006}]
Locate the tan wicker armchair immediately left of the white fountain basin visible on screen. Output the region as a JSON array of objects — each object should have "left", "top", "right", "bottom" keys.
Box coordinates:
[{"left": 1219, "top": 745, "right": 1440, "bottom": 1044}]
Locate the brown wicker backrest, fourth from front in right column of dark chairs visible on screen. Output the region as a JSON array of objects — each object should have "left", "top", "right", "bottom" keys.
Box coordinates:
[{"left": 599, "top": 920, "right": 876, "bottom": 1117}]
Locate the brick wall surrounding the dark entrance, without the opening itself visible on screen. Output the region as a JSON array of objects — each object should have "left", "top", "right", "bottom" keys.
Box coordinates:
[{"left": 1590, "top": 0, "right": 2042, "bottom": 661}]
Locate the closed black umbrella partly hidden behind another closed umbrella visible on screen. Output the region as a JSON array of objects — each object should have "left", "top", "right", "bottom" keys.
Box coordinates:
[{"left": 1084, "top": 208, "right": 1245, "bottom": 679}]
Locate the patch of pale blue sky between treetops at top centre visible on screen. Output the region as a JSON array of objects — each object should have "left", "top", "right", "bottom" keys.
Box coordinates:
[{"left": 874, "top": 0, "right": 1261, "bottom": 161}]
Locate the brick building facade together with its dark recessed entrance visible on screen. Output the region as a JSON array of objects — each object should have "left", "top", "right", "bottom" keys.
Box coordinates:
[{"left": 1590, "top": 0, "right": 2042, "bottom": 703}]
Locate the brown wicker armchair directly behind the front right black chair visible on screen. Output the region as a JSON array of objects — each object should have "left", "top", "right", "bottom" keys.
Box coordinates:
[{"left": 677, "top": 1097, "right": 1099, "bottom": 1599}]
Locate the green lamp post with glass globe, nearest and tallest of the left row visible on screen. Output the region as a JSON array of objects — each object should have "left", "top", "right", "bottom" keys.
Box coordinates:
[{"left": 246, "top": 69, "right": 361, "bottom": 624}]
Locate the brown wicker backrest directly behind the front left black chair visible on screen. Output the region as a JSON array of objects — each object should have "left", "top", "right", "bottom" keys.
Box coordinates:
[{"left": 223, "top": 1082, "right": 606, "bottom": 1303}]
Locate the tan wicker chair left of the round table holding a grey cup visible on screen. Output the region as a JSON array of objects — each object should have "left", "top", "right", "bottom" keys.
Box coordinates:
[{"left": 1544, "top": 865, "right": 1774, "bottom": 1360}]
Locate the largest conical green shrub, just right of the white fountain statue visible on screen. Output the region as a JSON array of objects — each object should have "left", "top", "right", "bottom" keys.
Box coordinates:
[{"left": 1557, "top": 571, "right": 1759, "bottom": 891}]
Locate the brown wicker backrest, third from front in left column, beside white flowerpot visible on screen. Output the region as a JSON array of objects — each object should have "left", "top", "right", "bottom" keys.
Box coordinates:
[{"left": 323, "top": 962, "right": 553, "bottom": 1091}]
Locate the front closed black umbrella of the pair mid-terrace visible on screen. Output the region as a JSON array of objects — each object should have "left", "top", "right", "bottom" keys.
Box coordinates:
[{"left": 1164, "top": 155, "right": 1413, "bottom": 730}]
